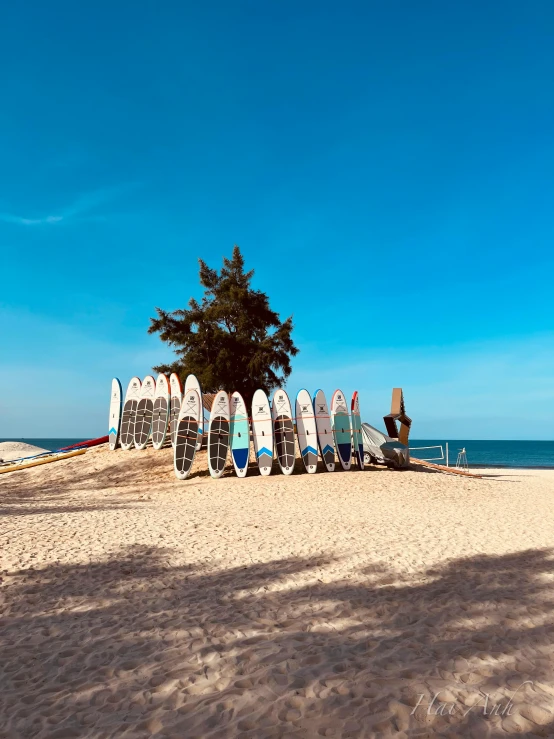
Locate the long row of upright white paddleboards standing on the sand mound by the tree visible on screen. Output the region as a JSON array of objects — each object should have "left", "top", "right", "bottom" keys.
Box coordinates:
[{"left": 109, "top": 374, "right": 364, "bottom": 480}]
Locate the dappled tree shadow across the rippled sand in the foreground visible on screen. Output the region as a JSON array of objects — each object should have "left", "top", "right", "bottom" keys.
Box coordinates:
[{"left": 0, "top": 546, "right": 554, "bottom": 739}]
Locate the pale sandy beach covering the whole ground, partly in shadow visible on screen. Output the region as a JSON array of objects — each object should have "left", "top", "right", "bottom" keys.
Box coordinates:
[{"left": 0, "top": 448, "right": 554, "bottom": 739}]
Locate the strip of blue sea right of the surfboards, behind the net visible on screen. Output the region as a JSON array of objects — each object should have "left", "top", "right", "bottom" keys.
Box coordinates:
[{"left": 410, "top": 439, "right": 554, "bottom": 468}]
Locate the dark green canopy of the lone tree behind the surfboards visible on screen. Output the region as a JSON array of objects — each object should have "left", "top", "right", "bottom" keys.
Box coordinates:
[{"left": 148, "top": 245, "right": 298, "bottom": 404}]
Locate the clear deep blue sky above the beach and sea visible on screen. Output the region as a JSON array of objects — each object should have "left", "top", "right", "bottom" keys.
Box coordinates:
[{"left": 0, "top": 0, "right": 554, "bottom": 439}]
